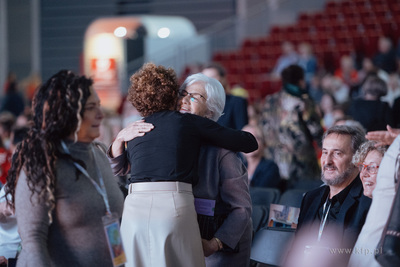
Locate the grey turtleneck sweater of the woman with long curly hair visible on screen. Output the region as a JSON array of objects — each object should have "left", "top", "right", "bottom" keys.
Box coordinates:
[{"left": 15, "top": 143, "right": 123, "bottom": 267}]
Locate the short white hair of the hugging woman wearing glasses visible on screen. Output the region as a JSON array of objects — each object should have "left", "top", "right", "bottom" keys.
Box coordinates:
[{"left": 179, "top": 73, "right": 226, "bottom": 121}]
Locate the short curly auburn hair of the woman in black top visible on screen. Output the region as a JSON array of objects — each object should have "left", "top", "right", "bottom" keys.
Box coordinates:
[{"left": 127, "top": 63, "right": 179, "bottom": 117}]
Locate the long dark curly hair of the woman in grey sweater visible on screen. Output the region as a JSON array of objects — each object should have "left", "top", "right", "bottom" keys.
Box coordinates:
[{"left": 6, "top": 70, "right": 93, "bottom": 223}]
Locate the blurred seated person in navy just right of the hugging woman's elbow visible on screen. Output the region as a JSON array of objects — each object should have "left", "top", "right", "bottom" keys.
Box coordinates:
[{"left": 242, "top": 125, "right": 280, "bottom": 188}]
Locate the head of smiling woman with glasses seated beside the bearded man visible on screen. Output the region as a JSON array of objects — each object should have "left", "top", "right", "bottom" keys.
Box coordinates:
[{"left": 352, "top": 141, "right": 387, "bottom": 198}]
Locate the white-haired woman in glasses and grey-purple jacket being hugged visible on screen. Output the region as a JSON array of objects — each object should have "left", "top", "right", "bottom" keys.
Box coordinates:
[{"left": 109, "top": 73, "right": 252, "bottom": 267}]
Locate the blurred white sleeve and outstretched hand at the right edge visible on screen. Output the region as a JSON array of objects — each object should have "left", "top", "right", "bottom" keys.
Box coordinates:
[{"left": 348, "top": 126, "right": 400, "bottom": 267}]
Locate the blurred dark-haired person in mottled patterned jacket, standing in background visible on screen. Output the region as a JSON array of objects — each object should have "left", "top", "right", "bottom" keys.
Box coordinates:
[{"left": 261, "top": 65, "right": 323, "bottom": 191}]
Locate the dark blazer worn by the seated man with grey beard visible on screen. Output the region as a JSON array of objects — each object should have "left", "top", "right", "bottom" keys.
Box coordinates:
[{"left": 297, "top": 176, "right": 371, "bottom": 247}]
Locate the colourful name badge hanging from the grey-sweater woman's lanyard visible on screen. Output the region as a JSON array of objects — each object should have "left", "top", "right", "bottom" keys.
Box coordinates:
[{"left": 102, "top": 213, "right": 126, "bottom": 267}]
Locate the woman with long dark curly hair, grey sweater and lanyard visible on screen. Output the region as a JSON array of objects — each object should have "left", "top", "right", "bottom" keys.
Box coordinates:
[{"left": 6, "top": 70, "right": 123, "bottom": 267}]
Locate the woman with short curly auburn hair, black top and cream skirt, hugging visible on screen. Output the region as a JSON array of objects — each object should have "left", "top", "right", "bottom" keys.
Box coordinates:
[{"left": 108, "top": 63, "right": 257, "bottom": 267}]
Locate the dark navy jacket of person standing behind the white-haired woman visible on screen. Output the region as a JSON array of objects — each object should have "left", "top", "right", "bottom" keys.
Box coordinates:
[{"left": 217, "top": 95, "right": 249, "bottom": 130}]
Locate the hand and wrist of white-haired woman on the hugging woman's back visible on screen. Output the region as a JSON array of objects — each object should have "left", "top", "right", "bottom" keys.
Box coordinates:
[{"left": 111, "top": 120, "right": 154, "bottom": 158}]
